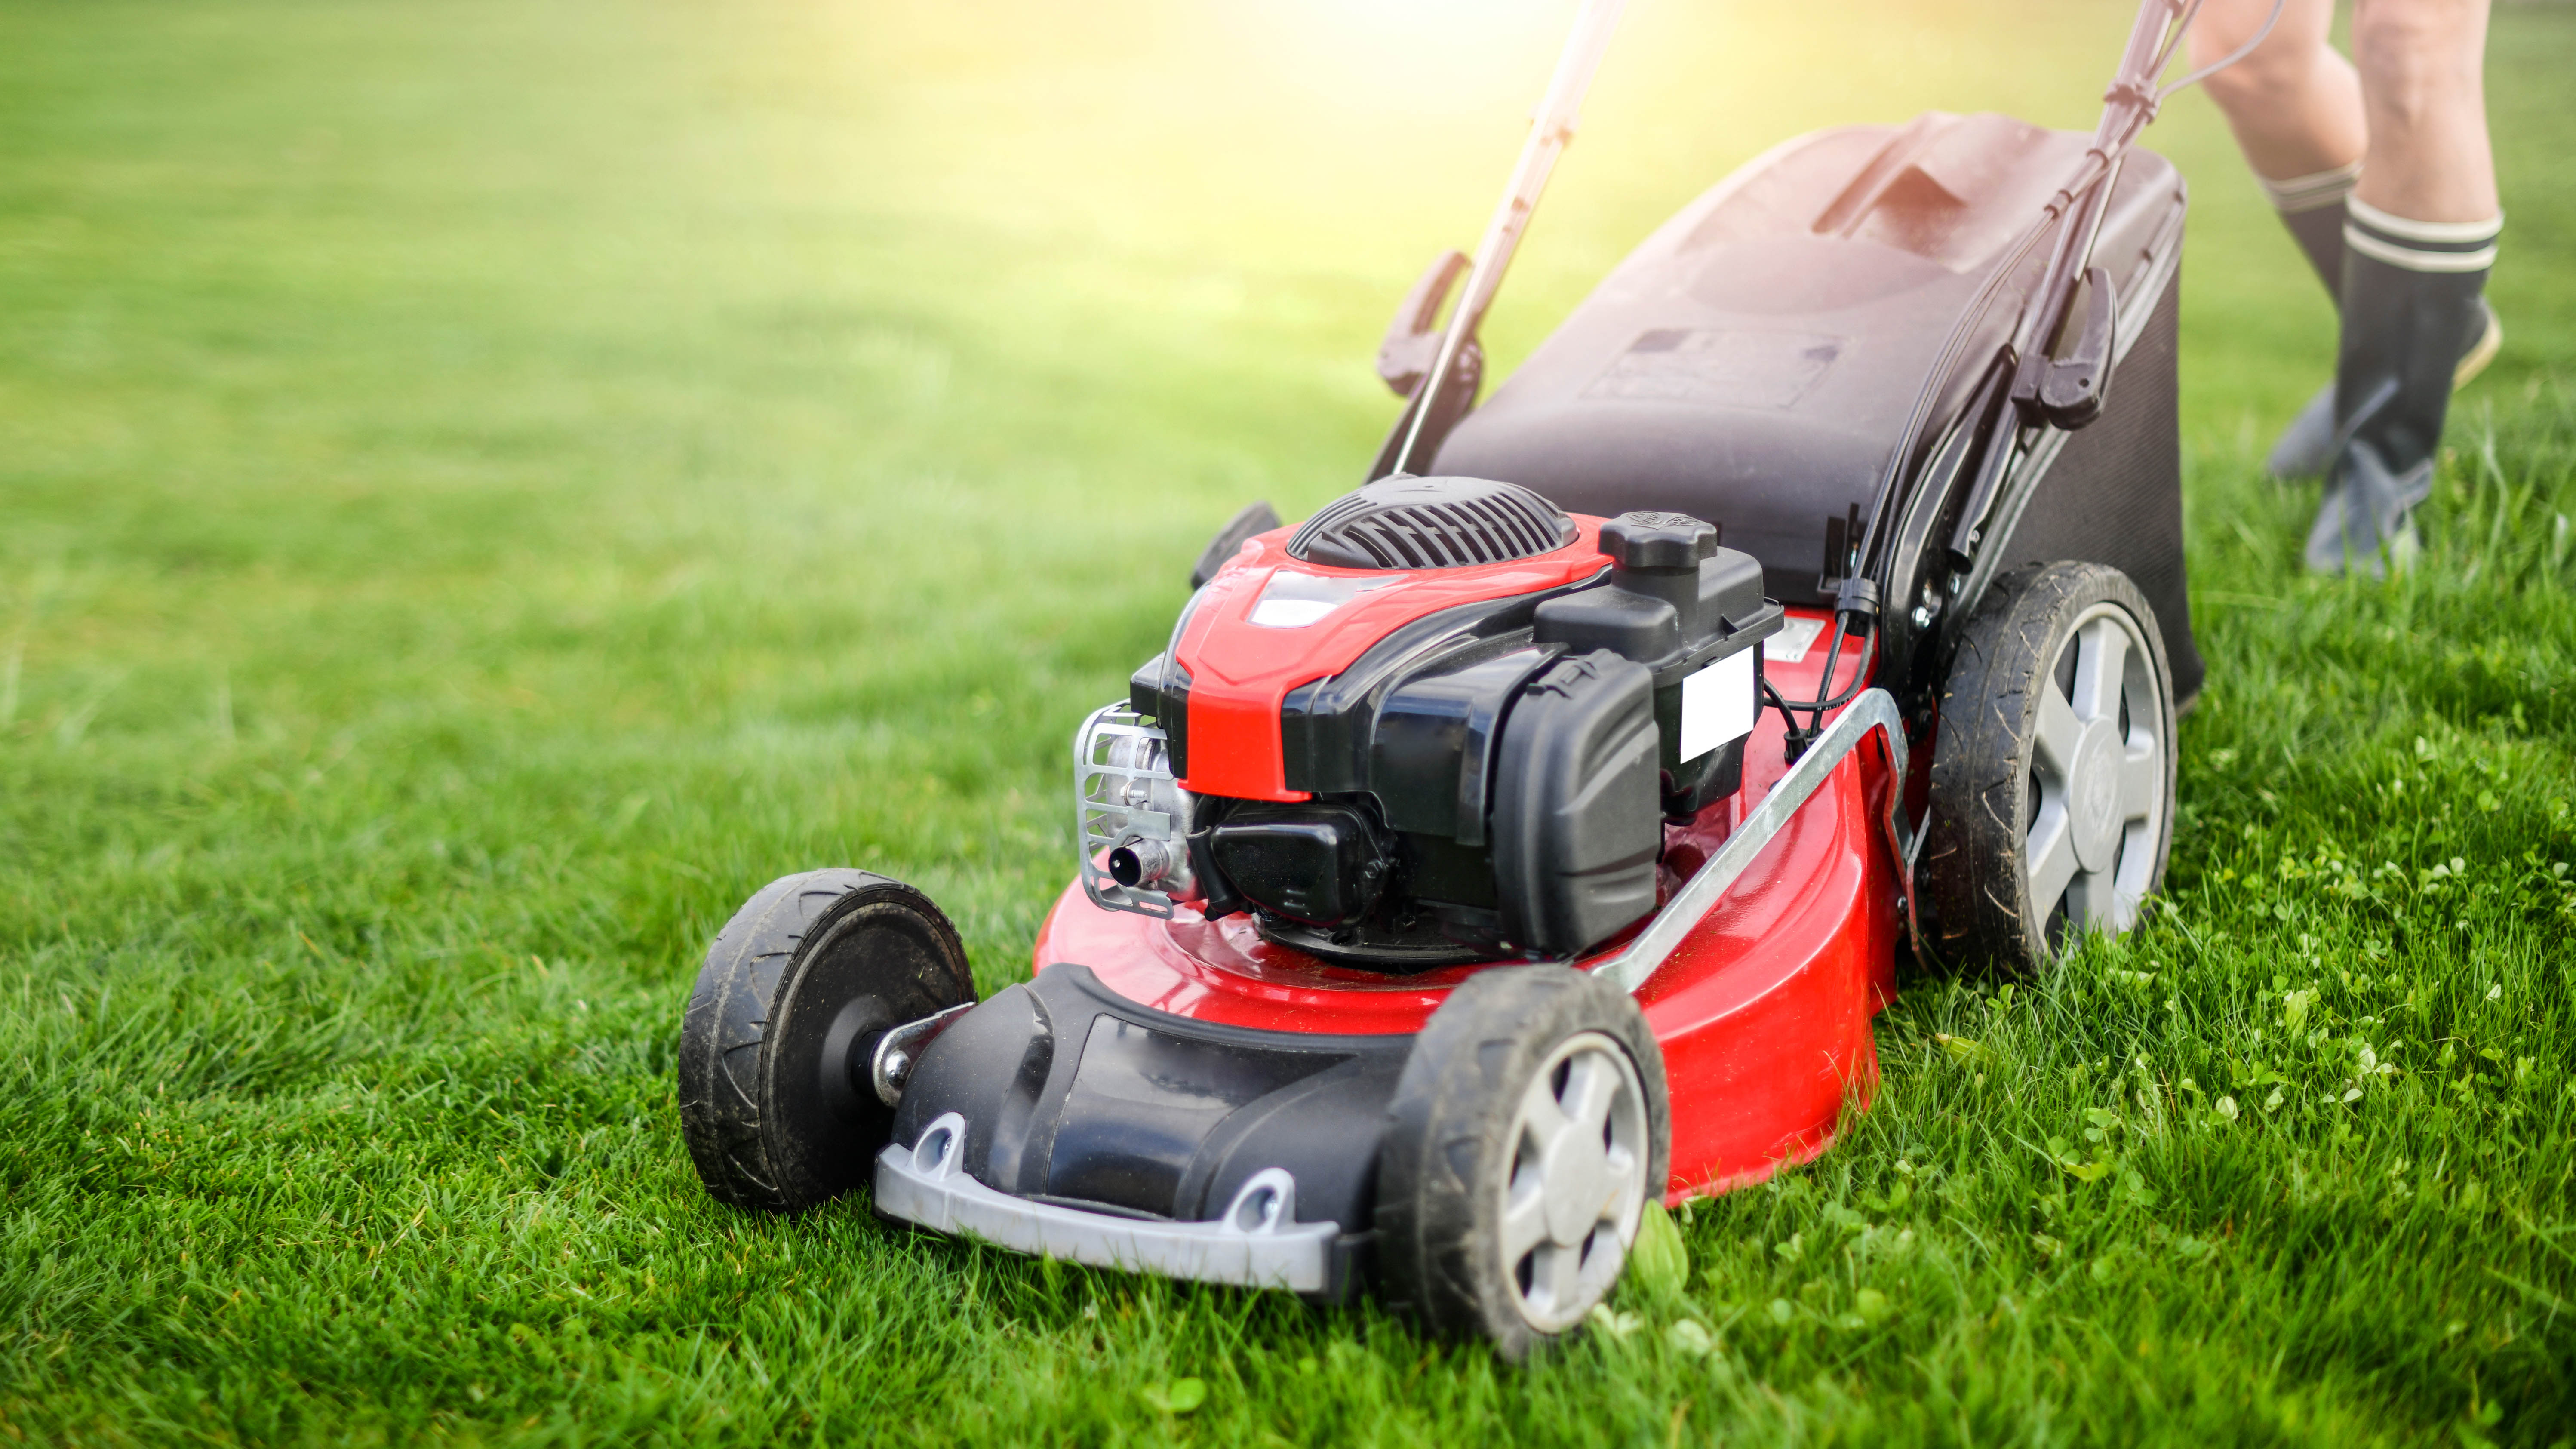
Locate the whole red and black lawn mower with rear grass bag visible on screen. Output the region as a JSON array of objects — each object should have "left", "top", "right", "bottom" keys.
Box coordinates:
[{"left": 680, "top": 0, "right": 2267, "bottom": 1356}]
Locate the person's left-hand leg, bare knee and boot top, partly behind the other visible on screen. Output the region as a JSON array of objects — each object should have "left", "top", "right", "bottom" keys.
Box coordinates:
[{"left": 2190, "top": 0, "right": 2370, "bottom": 291}]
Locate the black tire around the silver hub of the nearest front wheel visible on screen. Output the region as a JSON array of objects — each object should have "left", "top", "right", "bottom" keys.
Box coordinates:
[{"left": 1376, "top": 967, "right": 1672, "bottom": 1361}]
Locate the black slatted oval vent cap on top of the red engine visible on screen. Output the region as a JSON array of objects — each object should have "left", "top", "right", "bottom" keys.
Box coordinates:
[{"left": 1288, "top": 477, "right": 1574, "bottom": 570}]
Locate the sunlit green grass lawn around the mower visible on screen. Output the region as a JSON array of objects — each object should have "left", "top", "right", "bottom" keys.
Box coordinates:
[{"left": 0, "top": 0, "right": 2576, "bottom": 1449}]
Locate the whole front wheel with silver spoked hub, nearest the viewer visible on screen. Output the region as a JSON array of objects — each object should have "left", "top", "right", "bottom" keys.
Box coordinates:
[{"left": 1378, "top": 967, "right": 1672, "bottom": 1359}]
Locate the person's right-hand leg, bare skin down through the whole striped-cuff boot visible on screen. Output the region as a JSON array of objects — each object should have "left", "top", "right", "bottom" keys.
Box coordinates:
[{"left": 2308, "top": 0, "right": 2504, "bottom": 572}]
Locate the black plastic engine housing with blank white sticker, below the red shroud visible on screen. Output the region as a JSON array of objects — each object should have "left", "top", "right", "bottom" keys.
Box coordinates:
[{"left": 1131, "top": 492, "right": 1783, "bottom": 972}]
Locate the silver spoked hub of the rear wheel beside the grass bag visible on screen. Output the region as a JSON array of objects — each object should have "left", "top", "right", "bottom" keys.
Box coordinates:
[{"left": 2022, "top": 603, "right": 2172, "bottom": 936}]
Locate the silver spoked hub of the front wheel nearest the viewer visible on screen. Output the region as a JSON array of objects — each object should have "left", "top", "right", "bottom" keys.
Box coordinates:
[{"left": 1502, "top": 1031, "right": 1649, "bottom": 1333}]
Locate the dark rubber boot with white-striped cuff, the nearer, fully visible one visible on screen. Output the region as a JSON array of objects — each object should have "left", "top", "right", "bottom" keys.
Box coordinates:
[{"left": 2305, "top": 196, "right": 2504, "bottom": 578}]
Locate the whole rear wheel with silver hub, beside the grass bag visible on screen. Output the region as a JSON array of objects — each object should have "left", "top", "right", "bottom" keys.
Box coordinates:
[{"left": 1922, "top": 562, "right": 2174, "bottom": 972}]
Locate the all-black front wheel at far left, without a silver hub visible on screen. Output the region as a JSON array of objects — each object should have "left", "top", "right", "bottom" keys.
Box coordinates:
[{"left": 680, "top": 869, "right": 974, "bottom": 1212}]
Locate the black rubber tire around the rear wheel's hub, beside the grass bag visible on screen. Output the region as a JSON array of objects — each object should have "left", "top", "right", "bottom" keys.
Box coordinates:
[{"left": 1917, "top": 562, "right": 2177, "bottom": 977}]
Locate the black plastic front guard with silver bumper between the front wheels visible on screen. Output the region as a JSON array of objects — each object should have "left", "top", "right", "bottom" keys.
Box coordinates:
[{"left": 876, "top": 959, "right": 1412, "bottom": 1299}]
